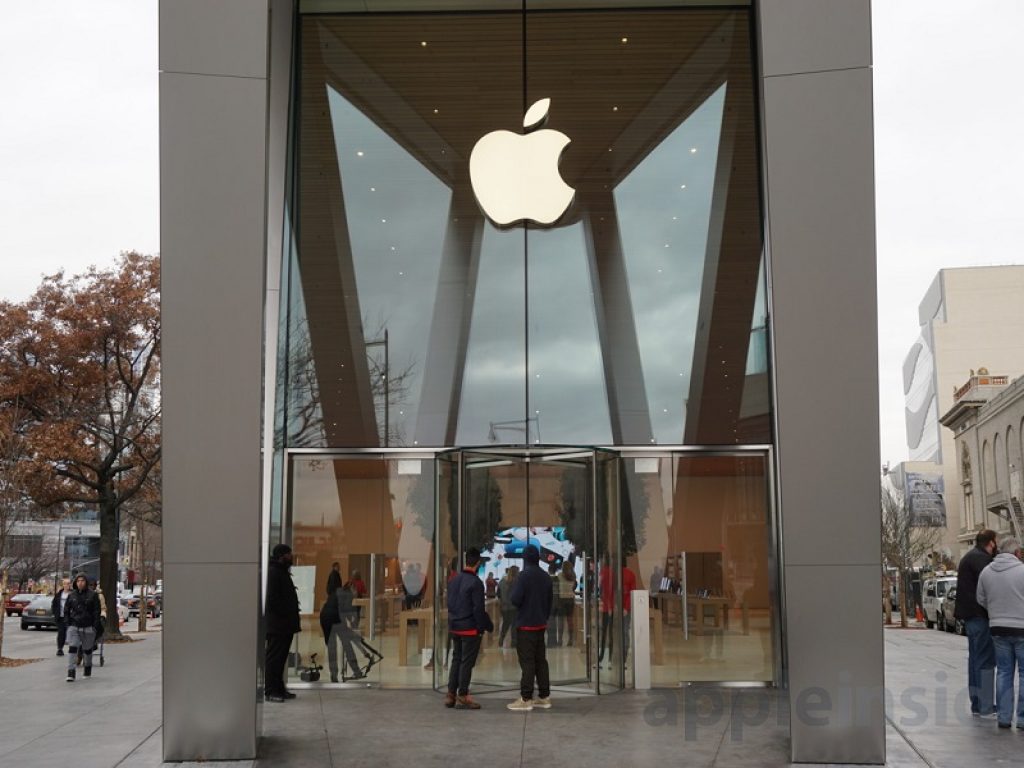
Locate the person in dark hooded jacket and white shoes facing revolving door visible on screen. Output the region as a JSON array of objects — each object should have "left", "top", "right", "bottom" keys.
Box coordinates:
[{"left": 508, "top": 545, "right": 552, "bottom": 712}]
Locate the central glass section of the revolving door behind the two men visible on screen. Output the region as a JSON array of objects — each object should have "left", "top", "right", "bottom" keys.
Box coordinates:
[{"left": 448, "top": 449, "right": 598, "bottom": 687}]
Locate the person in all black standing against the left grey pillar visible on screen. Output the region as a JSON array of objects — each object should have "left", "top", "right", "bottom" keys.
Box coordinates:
[{"left": 263, "top": 544, "right": 301, "bottom": 701}]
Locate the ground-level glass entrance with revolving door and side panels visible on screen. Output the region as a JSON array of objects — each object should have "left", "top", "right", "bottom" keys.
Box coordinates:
[{"left": 283, "top": 445, "right": 778, "bottom": 692}]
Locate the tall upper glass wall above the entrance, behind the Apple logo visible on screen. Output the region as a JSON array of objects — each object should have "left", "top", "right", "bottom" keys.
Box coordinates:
[{"left": 286, "top": 7, "right": 770, "bottom": 446}]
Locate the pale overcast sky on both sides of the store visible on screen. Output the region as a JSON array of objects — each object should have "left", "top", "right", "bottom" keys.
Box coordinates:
[{"left": 0, "top": 0, "right": 1024, "bottom": 462}]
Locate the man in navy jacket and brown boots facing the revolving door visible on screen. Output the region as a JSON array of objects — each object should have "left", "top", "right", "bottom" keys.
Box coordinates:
[{"left": 444, "top": 547, "right": 495, "bottom": 710}]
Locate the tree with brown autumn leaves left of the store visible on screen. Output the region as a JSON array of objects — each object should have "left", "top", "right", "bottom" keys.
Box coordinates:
[{"left": 0, "top": 253, "right": 161, "bottom": 635}]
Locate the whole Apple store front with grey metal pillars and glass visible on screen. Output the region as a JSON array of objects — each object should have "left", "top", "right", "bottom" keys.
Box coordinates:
[{"left": 161, "top": 0, "right": 885, "bottom": 763}]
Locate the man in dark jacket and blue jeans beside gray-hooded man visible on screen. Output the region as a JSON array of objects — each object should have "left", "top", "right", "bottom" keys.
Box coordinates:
[{"left": 953, "top": 530, "right": 996, "bottom": 718}]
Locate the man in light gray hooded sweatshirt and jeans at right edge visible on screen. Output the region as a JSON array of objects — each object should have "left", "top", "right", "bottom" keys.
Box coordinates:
[{"left": 978, "top": 536, "right": 1024, "bottom": 729}]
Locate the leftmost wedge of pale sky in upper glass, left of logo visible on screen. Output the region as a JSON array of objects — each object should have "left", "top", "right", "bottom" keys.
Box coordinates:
[{"left": 328, "top": 88, "right": 452, "bottom": 445}]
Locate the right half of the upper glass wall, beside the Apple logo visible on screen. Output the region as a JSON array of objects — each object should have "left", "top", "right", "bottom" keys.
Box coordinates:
[{"left": 524, "top": 10, "right": 770, "bottom": 444}]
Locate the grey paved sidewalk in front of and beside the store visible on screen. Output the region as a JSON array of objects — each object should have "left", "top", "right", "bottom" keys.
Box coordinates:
[{"left": 0, "top": 629, "right": 1024, "bottom": 768}]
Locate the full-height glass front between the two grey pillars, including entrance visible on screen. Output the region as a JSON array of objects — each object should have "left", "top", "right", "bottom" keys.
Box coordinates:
[{"left": 270, "top": 2, "right": 776, "bottom": 691}]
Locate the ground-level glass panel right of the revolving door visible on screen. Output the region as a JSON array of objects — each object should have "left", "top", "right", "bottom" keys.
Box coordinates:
[{"left": 622, "top": 454, "right": 775, "bottom": 686}]
